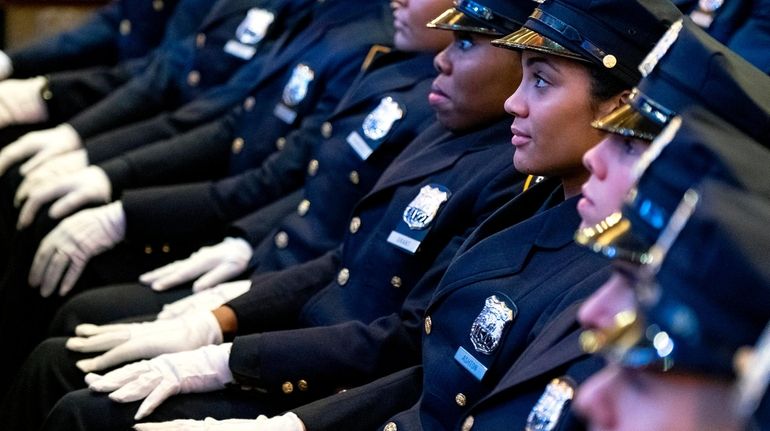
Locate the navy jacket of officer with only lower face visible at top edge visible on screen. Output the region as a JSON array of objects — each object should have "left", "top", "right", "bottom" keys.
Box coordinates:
[{"left": 115, "top": 52, "right": 435, "bottom": 271}]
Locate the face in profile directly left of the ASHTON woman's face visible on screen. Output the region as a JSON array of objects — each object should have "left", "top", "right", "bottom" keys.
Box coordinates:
[{"left": 428, "top": 32, "right": 521, "bottom": 131}]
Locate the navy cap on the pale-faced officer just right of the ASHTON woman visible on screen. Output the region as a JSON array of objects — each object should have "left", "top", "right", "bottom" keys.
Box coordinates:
[{"left": 594, "top": 18, "right": 770, "bottom": 145}]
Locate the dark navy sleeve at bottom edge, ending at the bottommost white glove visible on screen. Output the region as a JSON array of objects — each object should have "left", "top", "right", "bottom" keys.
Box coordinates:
[{"left": 292, "top": 366, "right": 422, "bottom": 431}]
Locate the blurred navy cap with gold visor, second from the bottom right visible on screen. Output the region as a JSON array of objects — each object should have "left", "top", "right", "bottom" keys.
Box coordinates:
[{"left": 576, "top": 107, "right": 770, "bottom": 265}]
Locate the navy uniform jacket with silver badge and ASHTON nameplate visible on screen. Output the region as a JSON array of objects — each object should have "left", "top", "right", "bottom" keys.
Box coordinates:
[{"left": 376, "top": 179, "right": 609, "bottom": 430}]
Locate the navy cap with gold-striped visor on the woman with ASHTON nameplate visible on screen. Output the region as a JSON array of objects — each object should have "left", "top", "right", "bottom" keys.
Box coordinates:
[{"left": 492, "top": 0, "right": 682, "bottom": 87}]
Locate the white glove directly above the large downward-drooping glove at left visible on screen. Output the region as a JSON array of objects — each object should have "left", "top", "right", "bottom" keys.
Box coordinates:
[{"left": 15, "top": 165, "right": 112, "bottom": 230}]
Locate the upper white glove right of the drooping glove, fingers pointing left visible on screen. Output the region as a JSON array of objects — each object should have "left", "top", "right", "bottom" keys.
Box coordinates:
[{"left": 139, "top": 237, "right": 254, "bottom": 292}]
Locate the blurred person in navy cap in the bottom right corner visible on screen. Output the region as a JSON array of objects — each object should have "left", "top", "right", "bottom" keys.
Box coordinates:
[{"left": 576, "top": 181, "right": 770, "bottom": 431}]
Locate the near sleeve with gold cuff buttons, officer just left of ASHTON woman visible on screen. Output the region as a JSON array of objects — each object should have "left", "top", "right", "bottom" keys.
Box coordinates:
[{"left": 225, "top": 236, "right": 464, "bottom": 396}]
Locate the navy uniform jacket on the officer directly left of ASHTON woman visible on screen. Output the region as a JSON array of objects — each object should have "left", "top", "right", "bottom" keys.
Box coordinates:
[{"left": 218, "top": 119, "right": 522, "bottom": 397}]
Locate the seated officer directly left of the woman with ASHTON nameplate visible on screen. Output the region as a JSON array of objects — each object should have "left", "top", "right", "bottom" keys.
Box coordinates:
[{"left": 0, "top": 2, "right": 528, "bottom": 426}]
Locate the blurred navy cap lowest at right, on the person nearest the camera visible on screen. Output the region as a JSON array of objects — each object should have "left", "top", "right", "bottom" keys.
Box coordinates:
[{"left": 608, "top": 180, "right": 770, "bottom": 378}]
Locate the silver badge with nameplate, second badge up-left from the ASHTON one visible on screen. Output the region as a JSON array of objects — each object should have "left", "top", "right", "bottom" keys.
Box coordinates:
[{"left": 347, "top": 96, "right": 405, "bottom": 160}]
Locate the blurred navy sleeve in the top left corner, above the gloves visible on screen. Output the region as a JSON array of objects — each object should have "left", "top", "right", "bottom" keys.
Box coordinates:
[{"left": 8, "top": 1, "right": 121, "bottom": 78}]
